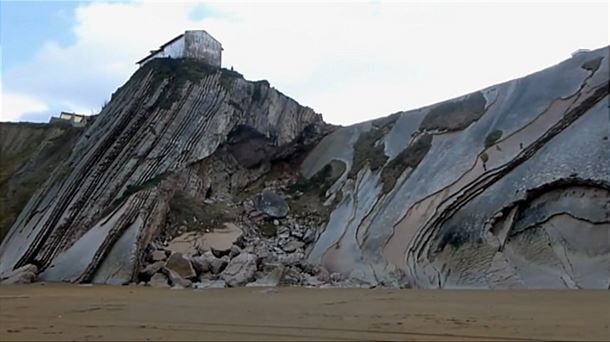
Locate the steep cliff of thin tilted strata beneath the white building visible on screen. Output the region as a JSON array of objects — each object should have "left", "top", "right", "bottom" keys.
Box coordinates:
[{"left": 0, "top": 60, "right": 326, "bottom": 283}]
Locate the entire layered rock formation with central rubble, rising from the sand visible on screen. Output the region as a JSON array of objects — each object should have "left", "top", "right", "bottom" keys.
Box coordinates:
[{"left": 0, "top": 47, "right": 610, "bottom": 288}]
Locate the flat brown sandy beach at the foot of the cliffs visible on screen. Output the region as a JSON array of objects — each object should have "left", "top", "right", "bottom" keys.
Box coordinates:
[{"left": 0, "top": 284, "right": 610, "bottom": 341}]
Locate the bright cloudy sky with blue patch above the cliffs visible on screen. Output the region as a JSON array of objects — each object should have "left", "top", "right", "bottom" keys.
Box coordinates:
[{"left": 0, "top": 0, "right": 609, "bottom": 125}]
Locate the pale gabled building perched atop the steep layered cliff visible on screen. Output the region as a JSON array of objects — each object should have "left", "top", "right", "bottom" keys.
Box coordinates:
[{"left": 137, "top": 30, "right": 222, "bottom": 67}]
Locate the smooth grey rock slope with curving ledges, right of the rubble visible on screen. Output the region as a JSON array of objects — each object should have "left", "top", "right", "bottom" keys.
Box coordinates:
[{"left": 302, "top": 48, "right": 610, "bottom": 288}]
